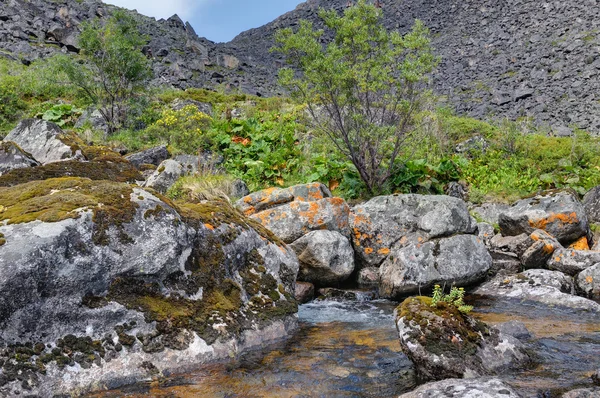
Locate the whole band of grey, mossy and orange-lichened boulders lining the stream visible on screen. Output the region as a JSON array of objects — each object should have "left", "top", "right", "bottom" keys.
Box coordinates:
[{"left": 0, "top": 120, "right": 600, "bottom": 397}]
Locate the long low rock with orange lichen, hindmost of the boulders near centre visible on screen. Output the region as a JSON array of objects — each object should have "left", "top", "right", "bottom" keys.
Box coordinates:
[{"left": 236, "top": 183, "right": 331, "bottom": 216}]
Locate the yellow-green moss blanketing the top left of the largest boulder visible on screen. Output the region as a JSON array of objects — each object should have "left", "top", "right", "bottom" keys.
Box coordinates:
[{"left": 0, "top": 177, "right": 138, "bottom": 245}]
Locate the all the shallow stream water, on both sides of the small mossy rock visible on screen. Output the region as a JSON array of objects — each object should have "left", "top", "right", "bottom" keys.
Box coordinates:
[{"left": 94, "top": 299, "right": 600, "bottom": 398}]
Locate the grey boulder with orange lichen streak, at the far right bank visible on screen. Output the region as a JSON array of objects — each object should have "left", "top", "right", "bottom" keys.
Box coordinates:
[{"left": 498, "top": 191, "right": 589, "bottom": 244}]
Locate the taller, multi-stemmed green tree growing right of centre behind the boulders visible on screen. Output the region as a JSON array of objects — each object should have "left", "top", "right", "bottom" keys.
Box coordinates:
[{"left": 273, "top": 0, "right": 437, "bottom": 194}]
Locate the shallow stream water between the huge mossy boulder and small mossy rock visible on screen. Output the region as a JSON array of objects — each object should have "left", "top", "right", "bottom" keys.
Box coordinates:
[{"left": 94, "top": 300, "right": 415, "bottom": 398}]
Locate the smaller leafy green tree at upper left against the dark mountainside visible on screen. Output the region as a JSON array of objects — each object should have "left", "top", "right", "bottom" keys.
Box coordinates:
[{"left": 61, "top": 11, "right": 152, "bottom": 132}]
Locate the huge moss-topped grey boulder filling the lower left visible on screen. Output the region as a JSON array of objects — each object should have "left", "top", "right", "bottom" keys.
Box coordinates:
[{"left": 0, "top": 177, "right": 298, "bottom": 397}]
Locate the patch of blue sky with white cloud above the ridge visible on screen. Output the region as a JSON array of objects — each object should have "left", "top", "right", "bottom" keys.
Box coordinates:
[{"left": 104, "top": 0, "right": 303, "bottom": 42}]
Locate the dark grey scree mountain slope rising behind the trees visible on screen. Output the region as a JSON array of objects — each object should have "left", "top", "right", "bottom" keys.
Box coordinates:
[{"left": 0, "top": 0, "right": 600, "bottom": 134}]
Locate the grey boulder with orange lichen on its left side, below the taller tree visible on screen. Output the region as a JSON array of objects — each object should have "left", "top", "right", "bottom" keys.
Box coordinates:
[{"left": 350, "top": 195, "right": 476, "bottom": 267}]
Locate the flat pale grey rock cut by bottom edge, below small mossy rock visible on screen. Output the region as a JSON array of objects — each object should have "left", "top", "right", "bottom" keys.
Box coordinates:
[{"left": 399, "top": 378, "right": 521, "bottom": 398}]
